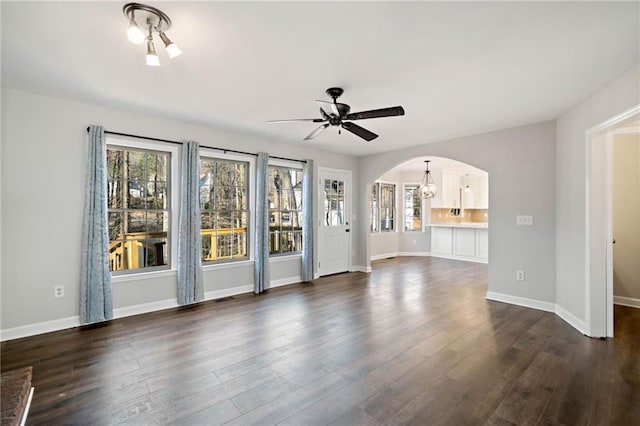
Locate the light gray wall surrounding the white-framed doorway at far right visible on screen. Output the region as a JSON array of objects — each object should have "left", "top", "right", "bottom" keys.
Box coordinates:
[{"left": 556, "top": 65, "right": 640, "bottom": 325}]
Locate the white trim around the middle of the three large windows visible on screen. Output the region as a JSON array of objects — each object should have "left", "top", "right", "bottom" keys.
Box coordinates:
[{"left": 198, "top": 147, "right": 256, "bottom": 262}]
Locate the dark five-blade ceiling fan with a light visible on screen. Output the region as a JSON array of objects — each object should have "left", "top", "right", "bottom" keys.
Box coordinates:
[{"left": 269, "top": 87, "right": 404, "bottom": 142}]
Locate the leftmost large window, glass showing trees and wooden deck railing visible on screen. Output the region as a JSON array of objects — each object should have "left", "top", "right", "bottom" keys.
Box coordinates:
[{"left": 107, "top": 145, "right": 171, "bottom": 272}]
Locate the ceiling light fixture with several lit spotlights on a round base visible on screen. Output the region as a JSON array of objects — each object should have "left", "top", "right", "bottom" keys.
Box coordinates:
[{"left": 122, "top": 3, "right": 182, "bottom": 67}]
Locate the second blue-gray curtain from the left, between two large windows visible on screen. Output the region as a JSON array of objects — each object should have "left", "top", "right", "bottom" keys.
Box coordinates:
[{"left": 178, "top": 141, "right": 204, "bottom": 305}]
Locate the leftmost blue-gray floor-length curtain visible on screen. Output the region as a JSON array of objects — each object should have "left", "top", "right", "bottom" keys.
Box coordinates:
[{"left": 80, "top": 126, "right": 113, "bottom": 324}]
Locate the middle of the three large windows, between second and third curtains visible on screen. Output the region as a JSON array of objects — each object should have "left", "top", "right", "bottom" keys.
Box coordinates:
[{"left": 200, "top": 157, "right": 249, "bottom": 262}]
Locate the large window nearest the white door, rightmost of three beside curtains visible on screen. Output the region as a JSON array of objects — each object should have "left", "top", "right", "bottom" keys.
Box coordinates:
[{"left": 268, "top": 165, "right": 302, "bottom": 255}]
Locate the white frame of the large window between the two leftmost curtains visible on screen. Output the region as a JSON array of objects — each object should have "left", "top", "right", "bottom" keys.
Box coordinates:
[{"left": 105, "top": 134, "right": 181, "bottom": 283}]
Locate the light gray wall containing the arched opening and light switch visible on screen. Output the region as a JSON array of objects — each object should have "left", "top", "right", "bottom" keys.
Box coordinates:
[{"left": 358, "top": 121, "right": 556, "bottom": 307}]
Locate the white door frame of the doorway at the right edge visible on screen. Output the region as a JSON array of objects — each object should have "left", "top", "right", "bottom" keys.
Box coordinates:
[{"left": 584, "top": 105, "right": 640, "bottom": 337}]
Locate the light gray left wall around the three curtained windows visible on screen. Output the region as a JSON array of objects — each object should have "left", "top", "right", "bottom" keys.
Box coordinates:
[{"left": 0, "top": 90, "right": 360, "bottom": 338}]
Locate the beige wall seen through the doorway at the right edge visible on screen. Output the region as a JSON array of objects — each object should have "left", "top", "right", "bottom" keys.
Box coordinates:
[{"left": 613, "top": 134, "right": 640, "bottom": 302}]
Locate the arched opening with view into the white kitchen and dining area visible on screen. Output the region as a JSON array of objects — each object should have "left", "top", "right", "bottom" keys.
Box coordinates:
[{"left": 367, "top": 156, "right": 489, "bottom": 263}]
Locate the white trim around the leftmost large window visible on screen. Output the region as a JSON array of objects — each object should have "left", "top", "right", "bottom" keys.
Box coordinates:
[{"left": 105, "top": 134, "right": 181, "bottom": 276}]
